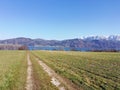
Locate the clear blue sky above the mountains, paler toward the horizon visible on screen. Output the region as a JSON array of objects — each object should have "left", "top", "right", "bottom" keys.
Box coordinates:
[{"left": 0, "top": 0, "right": 120, "bottom": 40}]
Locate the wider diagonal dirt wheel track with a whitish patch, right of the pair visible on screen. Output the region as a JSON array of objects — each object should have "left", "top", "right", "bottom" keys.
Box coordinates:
[{"left": 36, "top": 58, "right": 80, "bottom": 90}]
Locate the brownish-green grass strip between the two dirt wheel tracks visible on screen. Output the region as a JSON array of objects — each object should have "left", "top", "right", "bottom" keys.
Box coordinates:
[{"left": 30, "top": 52, "right": 58, "bottom": 90}]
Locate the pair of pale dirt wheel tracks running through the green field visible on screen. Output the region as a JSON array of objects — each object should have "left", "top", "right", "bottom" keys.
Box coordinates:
[{"left": 25, "top": 53, "right": 77, "bottom": 90}]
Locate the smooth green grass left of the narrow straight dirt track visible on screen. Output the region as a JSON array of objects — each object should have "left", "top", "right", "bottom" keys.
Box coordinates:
[{"left": 0, "top": 51, "right": 27, "bottom": 90}]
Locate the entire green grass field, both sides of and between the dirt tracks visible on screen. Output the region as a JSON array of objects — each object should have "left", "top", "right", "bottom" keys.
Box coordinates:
[{"left": 0, "top": 51, "right": 120, "bottom": 90}]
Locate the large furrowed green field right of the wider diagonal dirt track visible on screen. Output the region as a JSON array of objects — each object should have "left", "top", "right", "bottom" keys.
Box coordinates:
[{"left": 32, "top": 51, "right": 120, "bottom": 90}]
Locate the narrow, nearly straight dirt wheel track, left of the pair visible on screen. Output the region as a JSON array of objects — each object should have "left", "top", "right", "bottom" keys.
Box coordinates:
[{"left": 25, "top": 54, "right": 34, "bottom": 90}]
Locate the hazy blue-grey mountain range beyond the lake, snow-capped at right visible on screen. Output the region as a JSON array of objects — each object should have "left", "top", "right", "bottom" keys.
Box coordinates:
[{"left": 0, "top": 35, "right": 120, "bottom": 50}]
